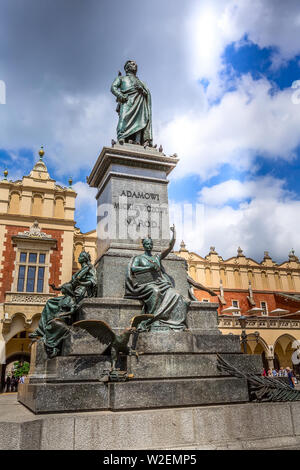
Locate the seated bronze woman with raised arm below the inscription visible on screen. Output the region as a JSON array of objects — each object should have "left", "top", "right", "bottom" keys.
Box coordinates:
[{"left": 125, "top": 226, "right": 190, "bottom": 331}]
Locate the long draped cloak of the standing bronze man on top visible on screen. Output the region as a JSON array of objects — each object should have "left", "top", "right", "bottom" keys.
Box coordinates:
[{"left": 112, "top": 76, "right": 152, "bottom": 143}]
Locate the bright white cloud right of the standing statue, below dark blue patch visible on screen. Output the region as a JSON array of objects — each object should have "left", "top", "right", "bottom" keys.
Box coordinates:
[{"left": 159, "top": 75, "right": 300, "bottom": 179}]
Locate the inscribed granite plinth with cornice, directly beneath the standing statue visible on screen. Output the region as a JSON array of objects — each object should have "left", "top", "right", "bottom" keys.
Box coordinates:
[{"left": 88, "top": 144, "right": 178, "bottom": 255}]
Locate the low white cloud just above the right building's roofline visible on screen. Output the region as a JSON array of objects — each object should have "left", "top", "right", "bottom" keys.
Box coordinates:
[{"left": 180, "top": 177, "right": 300, "bottom": 262}]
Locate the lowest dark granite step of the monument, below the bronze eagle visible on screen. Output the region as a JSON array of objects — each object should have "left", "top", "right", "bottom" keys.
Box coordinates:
[{"left": 18, "top": 377, "right": 249, "bottom": 414}]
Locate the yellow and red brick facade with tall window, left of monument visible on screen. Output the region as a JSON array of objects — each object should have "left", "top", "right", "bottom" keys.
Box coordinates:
[{"left": 0, "top": 149, "right": 96, "bottom": 390}]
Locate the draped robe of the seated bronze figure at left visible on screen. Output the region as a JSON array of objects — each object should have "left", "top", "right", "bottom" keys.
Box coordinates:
[{"left": 34, "top": 263, "right": 97, "bottom": 349}]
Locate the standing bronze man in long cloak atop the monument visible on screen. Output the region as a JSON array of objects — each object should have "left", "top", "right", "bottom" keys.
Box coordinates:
[{"left": 111, "top": 60, "right": 152, "bottom": 146}]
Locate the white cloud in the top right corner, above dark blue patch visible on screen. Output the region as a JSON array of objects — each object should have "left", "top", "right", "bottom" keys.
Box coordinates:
[{"left": 187, "top": 0, "right": 300, "bottom": 92}]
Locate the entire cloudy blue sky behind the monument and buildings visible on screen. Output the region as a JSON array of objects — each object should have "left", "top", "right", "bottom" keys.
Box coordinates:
[{"left": 0, "top": 0, "right": 300, "bottom": 262}]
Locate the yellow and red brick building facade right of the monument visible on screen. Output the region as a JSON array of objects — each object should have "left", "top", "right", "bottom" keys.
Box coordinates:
[{"left": 177, "top": 242, "right": 300, "bottom": 368}]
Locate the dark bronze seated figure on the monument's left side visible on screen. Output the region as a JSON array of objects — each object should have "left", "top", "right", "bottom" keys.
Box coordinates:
[{"left": 29, "top": 251, "right": 97, "bottom": 358}]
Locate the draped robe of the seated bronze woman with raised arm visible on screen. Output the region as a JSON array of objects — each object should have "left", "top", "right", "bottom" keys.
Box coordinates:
[{"left": 125, "top": 255, "right": 188, "bottom": 330}]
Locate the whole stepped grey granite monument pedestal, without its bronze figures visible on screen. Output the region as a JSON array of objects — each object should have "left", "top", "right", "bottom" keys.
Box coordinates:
[{"left": 18, "top": 144, "right": 262, "bottom": 413}]
